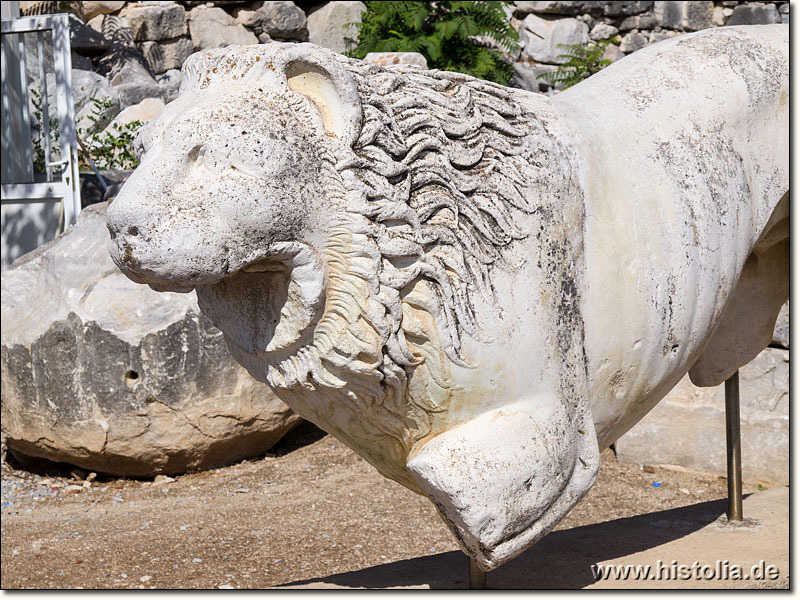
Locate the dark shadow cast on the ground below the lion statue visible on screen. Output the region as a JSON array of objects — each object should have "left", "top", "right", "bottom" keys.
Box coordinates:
[{"left": 279, "top": 499, "right": 727, "bottom": 589}]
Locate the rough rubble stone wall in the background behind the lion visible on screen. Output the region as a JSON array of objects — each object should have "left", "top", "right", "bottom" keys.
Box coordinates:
[{"left": 20, "top": 0, "right": 789, "bottom": 110}]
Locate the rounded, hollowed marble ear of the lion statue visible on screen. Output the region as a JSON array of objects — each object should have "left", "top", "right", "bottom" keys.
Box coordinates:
[{"left": 285, "top": 47, "right": 362, "bottom": 145}]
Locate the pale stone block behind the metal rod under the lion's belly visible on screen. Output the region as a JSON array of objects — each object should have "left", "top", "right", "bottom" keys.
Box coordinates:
[{"left": 615, "top": 349, "right": 789, "bottom": 485}]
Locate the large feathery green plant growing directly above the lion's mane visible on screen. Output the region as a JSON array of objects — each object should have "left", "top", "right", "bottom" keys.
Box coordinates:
[{"left": 347, "top": 2, "right": 519, "bottom": 85}]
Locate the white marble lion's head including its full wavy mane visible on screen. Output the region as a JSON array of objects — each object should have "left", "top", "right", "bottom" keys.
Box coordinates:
[{"left": 108, "top": 44, "right": 568, "bottom": 489}]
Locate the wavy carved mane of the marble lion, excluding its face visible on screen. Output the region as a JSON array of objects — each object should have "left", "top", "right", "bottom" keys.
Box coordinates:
[{"left": 190, "top": 55, "right": 574, "bottom": 489}]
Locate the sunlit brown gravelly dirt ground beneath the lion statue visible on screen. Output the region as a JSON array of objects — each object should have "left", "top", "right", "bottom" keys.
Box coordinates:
[{"left": 2, "top": 424, "right": 776, "bottom": 589}]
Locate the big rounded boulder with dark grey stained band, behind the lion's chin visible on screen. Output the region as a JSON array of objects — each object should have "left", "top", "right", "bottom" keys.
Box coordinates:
[{"left": 2, "top": 204, "right": 298, "bottom": 476}]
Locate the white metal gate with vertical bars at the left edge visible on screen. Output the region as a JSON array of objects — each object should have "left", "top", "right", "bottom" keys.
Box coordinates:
[{"left": 0, "top": 3, "right": 81, "bottom": 268}]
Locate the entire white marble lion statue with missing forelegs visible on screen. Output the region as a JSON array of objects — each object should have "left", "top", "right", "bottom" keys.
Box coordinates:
[{"left": 108, "top": 25, "right": 789, "bottom": 570}]
